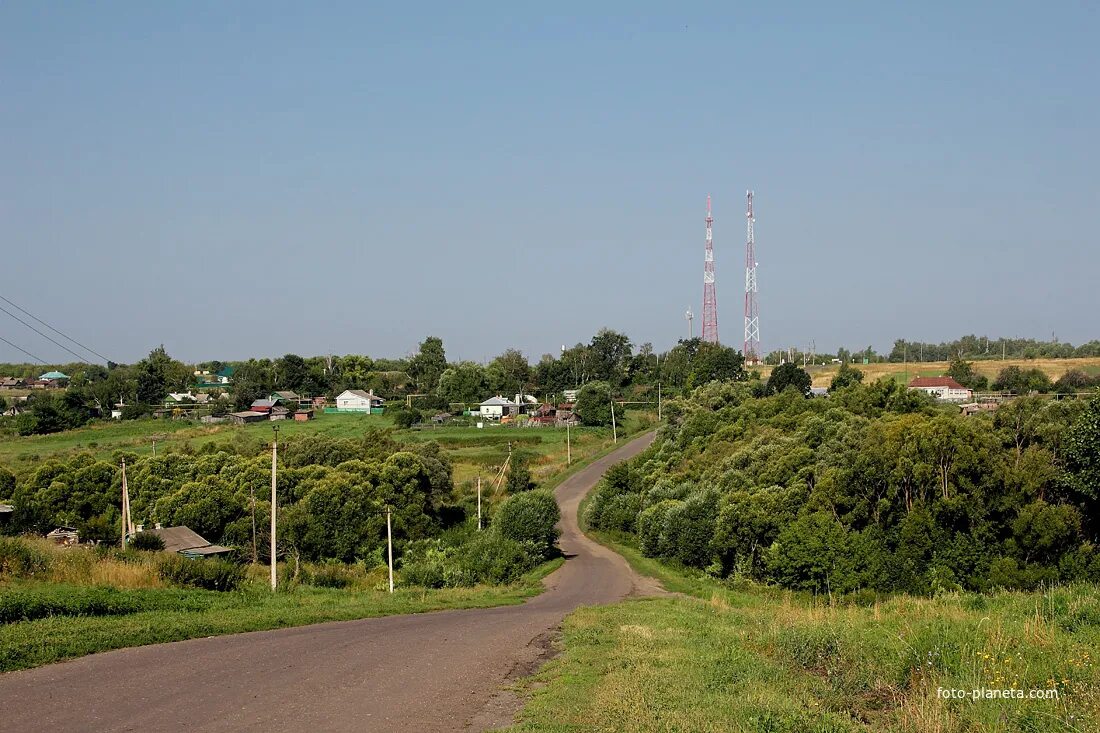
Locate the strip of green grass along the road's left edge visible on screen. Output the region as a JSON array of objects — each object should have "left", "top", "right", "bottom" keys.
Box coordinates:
[{"left": 0, "top": 560, "right": 561, "bottom": 671}]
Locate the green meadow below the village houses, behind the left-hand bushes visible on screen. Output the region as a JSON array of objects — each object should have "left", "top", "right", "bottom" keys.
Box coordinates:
[{"left": 0, "top": 412, "right": 650, "bottom": 486}]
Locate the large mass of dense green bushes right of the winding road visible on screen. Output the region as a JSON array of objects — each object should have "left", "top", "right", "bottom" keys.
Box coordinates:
[{"left": 586, "top": 380, "right": 1100, "bottom": 593}]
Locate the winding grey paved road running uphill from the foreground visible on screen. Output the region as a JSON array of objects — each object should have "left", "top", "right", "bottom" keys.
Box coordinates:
[{"left": 0, "top": 435, "right": 660, "bottom": 733}]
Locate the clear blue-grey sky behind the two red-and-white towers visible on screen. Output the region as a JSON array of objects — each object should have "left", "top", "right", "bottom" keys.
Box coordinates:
[{"left": 0, "top": 1, "right": 1100, "bottom": 361}]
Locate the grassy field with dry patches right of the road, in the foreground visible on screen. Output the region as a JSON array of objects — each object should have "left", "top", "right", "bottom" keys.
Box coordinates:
[{"left": 510, "top": 530, "right": 1100, "bottom": 733}]
